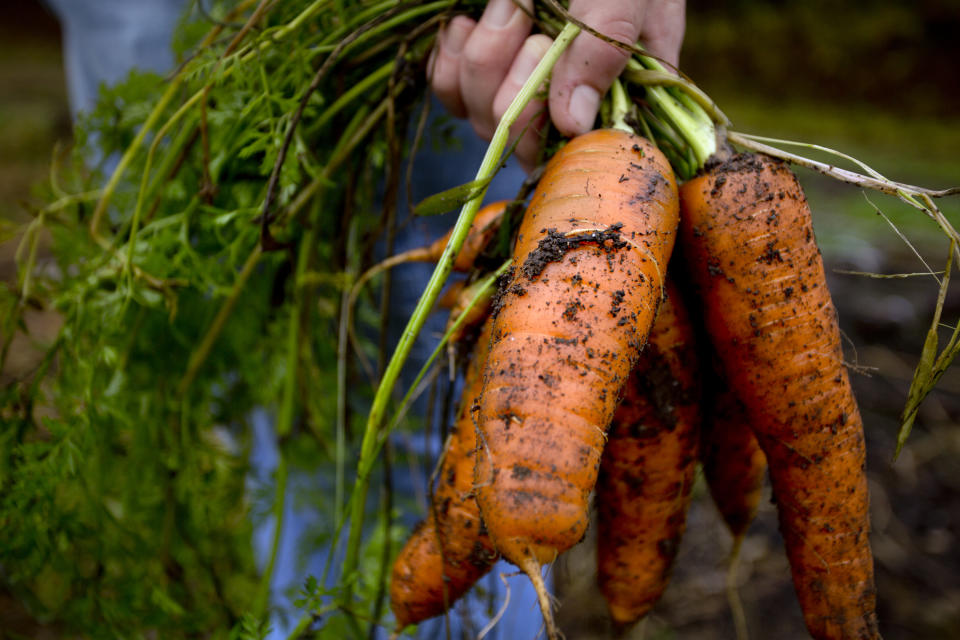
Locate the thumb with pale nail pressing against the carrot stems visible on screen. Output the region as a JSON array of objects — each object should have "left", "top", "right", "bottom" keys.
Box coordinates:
[{"left": 549, "top": 0, "right": 647, "bottom": 136}]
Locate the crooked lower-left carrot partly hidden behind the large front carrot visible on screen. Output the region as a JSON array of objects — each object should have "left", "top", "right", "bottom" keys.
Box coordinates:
[{"left": 390, "top": 322, "right": 497, "bottom": 631}]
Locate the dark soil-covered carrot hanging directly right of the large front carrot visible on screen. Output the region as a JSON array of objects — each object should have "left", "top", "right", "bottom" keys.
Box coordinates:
[{"left": 595, "top": 281, "right": 700, "bottom": 630}]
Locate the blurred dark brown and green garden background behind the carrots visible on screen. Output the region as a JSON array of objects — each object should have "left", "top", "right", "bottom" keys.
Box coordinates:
[{"left": 0, "top": 0, "right": 960, "bottom": 640}]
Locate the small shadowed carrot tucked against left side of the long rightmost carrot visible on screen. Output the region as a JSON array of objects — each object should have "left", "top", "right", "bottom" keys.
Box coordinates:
[{"left": 700, "top": 376, "right": 767, "bottom": 540}]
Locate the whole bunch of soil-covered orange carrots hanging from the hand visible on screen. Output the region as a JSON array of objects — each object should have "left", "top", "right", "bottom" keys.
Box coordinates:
[{"left": 364, "top": 13, "right": 956, "bottom": 640}]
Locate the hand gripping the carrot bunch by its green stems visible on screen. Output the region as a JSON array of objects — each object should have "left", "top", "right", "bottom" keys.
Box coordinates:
[{"left": 431, "top": 0, "right": 685, "bottom": 169}]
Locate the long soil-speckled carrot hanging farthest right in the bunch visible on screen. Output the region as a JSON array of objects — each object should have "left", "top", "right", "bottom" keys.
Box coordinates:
[{"left": 681, "top": 155, "right": 879, "bottom": 639}]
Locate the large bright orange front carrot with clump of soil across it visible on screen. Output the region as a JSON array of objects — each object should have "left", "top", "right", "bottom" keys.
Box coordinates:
[{"left": 476, "top": 129, "right": 678, "bottom": 638}]
